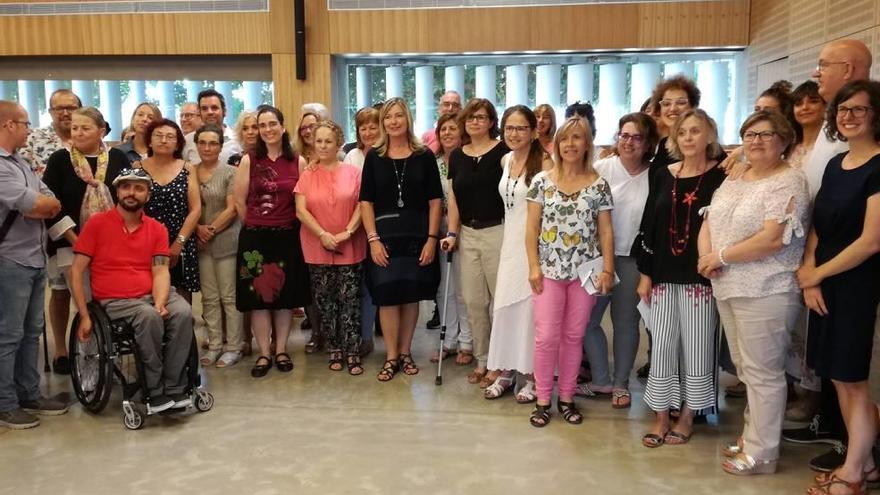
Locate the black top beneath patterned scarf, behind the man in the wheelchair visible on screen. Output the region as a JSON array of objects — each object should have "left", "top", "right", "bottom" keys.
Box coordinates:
[{"left": 43, "top": 148, "right": 129, "bottom": 256}]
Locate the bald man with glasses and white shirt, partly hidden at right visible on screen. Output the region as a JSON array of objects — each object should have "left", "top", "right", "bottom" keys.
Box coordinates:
[{"left": 782, "top": 39, "right": 874, "bottom": 472}]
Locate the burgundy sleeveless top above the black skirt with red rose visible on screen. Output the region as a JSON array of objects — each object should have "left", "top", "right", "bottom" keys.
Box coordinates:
[{"left": 244, "top": 153, "right": 299, "bottom": 227}]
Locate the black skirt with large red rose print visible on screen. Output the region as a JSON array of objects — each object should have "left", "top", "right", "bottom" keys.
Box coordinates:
[{"left": 235, "top": 227, "right": 312, "bottom": 311}]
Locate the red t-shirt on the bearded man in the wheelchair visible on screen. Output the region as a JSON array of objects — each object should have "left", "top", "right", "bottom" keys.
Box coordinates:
[{"left": 73, "top": 208, "right": 170, "bottom": 301}]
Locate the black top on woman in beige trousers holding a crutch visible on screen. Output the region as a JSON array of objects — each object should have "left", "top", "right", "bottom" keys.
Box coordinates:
[{"left": 449, "top": 141, "right": 510, "bottom": 225}]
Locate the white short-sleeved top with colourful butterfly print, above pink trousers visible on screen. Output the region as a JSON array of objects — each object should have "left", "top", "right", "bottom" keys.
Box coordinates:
[{"left": 526, "top": 172, "right": 614, "bottom": 280}]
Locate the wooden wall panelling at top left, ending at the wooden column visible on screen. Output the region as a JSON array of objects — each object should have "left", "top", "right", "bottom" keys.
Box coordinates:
[{"left": 0, "top": 12, "right": 270, "bottom": 55}]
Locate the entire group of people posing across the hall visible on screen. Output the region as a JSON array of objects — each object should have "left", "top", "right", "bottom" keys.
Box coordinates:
[{"left": 0, "top": 36, "right": 880, "bottom": 493}]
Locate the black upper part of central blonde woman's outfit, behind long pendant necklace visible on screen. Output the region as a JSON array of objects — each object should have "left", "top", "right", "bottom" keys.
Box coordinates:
[{"left": 360, "top": 148, "right": 444, "bottom": 216}]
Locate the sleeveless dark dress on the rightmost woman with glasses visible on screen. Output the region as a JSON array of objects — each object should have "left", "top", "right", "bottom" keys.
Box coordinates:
[{"left": 807, "top": 153, "right": 880, "bottom": 382}]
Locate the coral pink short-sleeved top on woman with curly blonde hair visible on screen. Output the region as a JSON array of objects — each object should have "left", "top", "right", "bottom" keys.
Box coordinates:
[{"left": 294, "top": 163, "right": 367, "bottom": 265}]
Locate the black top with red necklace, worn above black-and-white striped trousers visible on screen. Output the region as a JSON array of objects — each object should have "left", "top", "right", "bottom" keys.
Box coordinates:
[{"left": 631, "top": 165, "right": 727, "bottom": 285}]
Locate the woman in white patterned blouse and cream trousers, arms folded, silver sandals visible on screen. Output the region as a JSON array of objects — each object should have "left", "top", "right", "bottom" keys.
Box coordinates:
[{"left": 697, "top": 111, "right": 810, "bottom": 475}]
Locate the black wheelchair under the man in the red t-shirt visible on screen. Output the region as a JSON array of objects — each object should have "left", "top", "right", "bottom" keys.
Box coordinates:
[{"left": 69, "top": 301, "right": 214, "bottom": 430}]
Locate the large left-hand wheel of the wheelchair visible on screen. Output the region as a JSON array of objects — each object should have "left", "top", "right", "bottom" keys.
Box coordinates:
[{"left": 69, "top": 315, "right": 113, "bottom": 414}]
